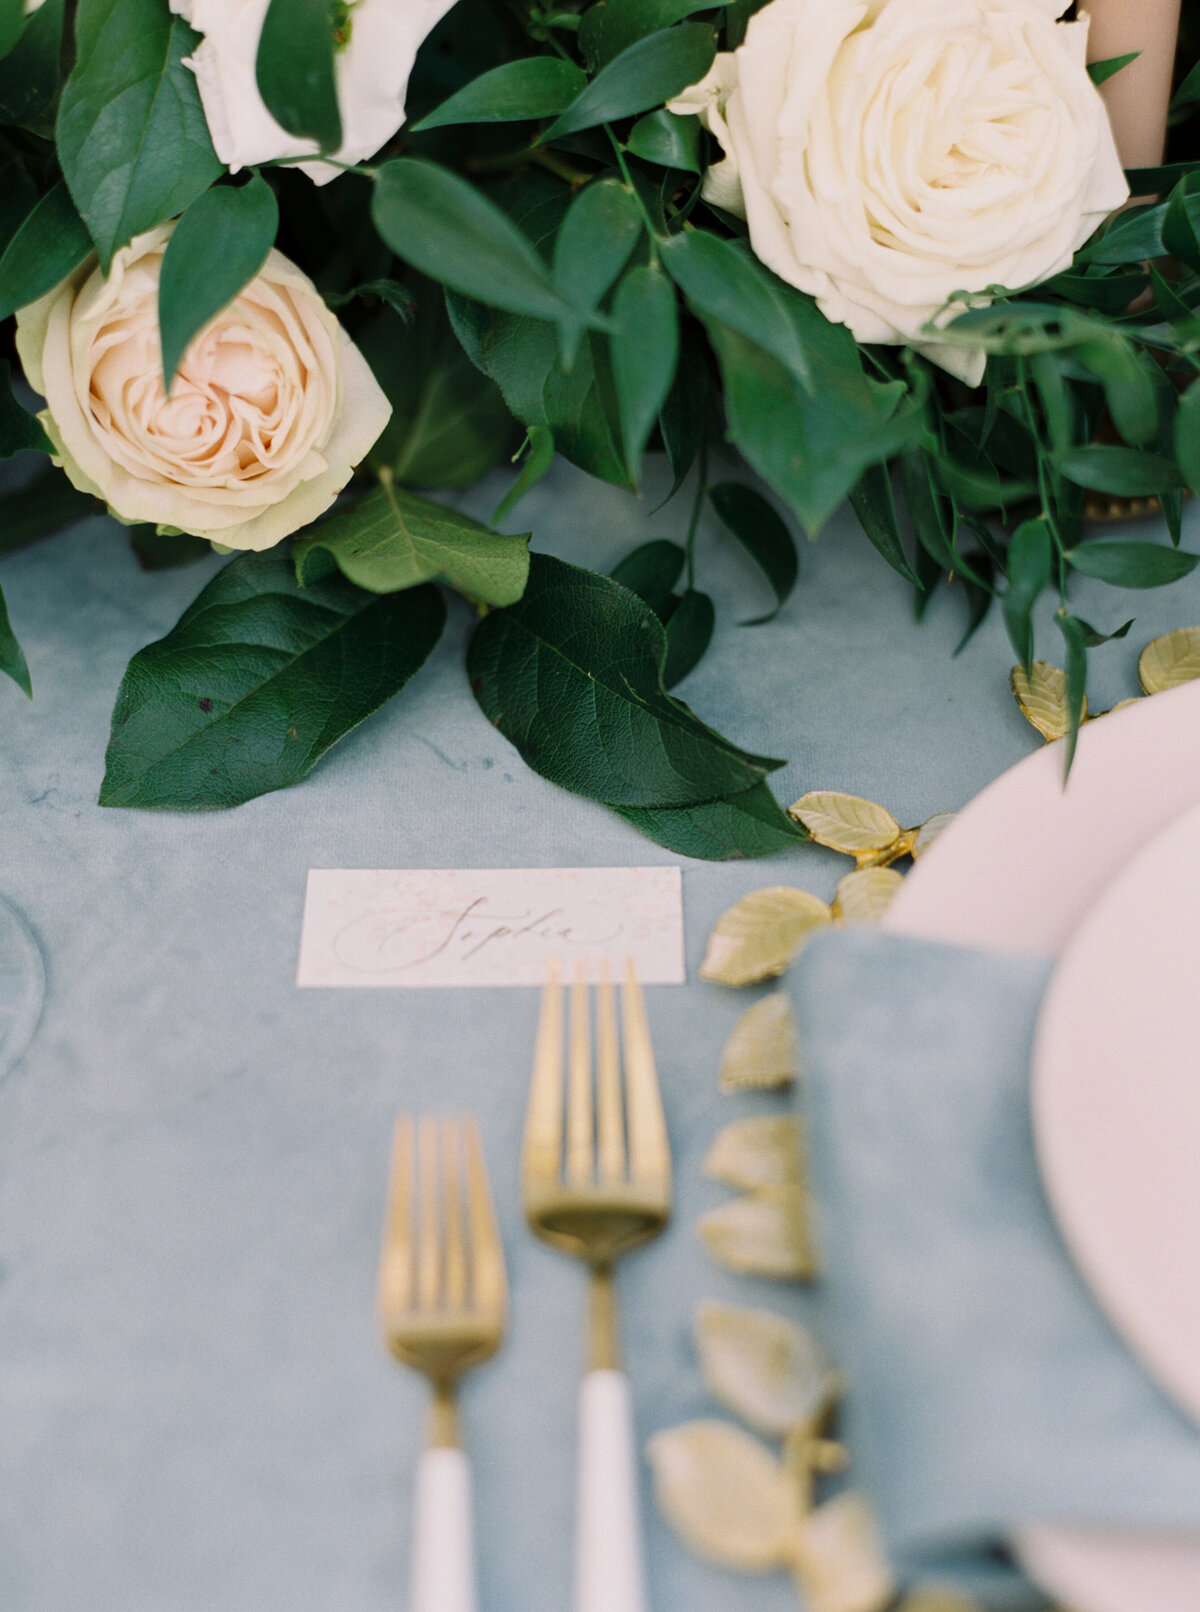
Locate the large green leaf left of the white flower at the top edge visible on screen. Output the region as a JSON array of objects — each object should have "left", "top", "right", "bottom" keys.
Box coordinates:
[{"left": 56, "top": 0, "right": 223, "bottom": 274}]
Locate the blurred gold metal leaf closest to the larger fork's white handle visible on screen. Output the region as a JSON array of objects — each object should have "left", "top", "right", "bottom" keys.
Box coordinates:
[{"left": 645, "top": 1420, "right": 800, "bottom": 1573}]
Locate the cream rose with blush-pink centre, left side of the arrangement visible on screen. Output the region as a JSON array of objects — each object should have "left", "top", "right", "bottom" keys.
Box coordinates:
[{"left": 16, "top": 224, "right": 392, "bottom": 548}]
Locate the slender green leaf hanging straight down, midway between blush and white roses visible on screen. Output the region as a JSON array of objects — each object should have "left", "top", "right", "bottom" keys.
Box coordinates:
[{"left": 612, "top": 262, "right": 679, "bottom": 482}]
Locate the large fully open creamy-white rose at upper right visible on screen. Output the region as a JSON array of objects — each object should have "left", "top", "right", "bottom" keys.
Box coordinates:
[{"left": 671, "top": 0, "right": 1129, "bottom": 385}]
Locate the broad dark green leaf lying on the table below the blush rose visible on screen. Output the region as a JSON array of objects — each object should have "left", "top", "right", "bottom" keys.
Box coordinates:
[{"left": 100, "top": 548, "right": 445, "bottom": 811}]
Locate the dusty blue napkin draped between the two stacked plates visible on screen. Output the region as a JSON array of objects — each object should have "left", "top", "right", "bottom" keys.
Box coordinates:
[{"left": 794, "top": 930, "right": 1200, "bottom": 1560}]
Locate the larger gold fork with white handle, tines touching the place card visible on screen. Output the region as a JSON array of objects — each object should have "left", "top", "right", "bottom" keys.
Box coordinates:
[{"left": 521, "top": 962, "right": 671, "bottom": 1612}]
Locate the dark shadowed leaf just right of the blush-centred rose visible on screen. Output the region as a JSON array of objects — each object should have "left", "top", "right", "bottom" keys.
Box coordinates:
[{"left": 355, "top": 285, "right": 513, "bottom": 487}]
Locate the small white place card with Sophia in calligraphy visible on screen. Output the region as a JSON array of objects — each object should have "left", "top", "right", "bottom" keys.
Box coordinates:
[{"left": 295, "top": 867, "right": 685, "bottom": 985}]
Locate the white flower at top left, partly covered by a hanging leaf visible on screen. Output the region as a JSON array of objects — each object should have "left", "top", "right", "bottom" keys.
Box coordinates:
[{"left": 171, "top": 0, "right": 455, "bottom": 185}]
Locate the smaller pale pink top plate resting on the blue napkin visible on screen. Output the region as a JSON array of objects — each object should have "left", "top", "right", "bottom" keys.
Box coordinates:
[{"left": 1032, "top": 808, "right": 1200, "bottom": 1422}]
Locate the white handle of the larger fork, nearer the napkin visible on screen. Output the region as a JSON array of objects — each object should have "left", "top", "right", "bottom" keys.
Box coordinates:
[{"left": 574, "top": 1370, "right": 645, "bottom": 1612}]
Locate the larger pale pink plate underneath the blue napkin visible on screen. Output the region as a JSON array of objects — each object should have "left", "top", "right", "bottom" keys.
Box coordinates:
[{"left": 884, "top": 682, "right": 1200, "bottom": 1612}]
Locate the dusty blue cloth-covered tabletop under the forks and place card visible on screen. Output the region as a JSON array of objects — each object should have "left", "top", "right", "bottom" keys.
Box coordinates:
[{"left": 0, "top": 457, "right": 1200, "bottom": 1612}]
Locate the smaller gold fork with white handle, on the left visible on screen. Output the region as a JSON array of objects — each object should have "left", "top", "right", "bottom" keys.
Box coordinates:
[{"left": 379, "top": 1114, "right": 506, "bottom": 1612}]
